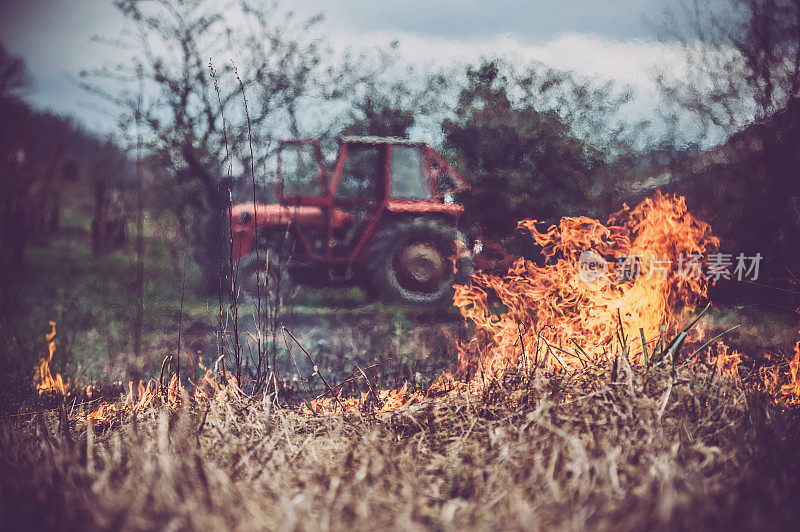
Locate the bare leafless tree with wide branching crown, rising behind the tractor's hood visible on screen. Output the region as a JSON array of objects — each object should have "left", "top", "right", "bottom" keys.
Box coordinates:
[{"left": 80, "top": 0, "right": 422, "bottom": 288}]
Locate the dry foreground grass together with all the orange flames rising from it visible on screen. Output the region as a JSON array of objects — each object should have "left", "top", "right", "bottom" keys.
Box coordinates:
[{"left": 9, "top": 195, "right": 800, "bottom": 530}]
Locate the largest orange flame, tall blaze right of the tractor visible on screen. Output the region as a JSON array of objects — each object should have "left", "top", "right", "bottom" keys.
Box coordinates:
[{"left": 455, "top": 192, "right": 719, "bottom": 382}]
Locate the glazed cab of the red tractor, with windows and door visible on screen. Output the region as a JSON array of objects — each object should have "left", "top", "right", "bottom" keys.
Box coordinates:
[{"left": 277, "top": 137, "right": 467, "bottom": 262}]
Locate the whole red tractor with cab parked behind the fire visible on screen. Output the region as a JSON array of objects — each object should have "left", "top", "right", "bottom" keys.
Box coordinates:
[{"left": 231, "top": 137, "right": 472, "bottom": 303}]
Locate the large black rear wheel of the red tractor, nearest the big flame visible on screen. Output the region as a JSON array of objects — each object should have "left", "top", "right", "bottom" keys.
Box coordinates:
[{"left": 367, "top": 218, "right": 472, "bottom": 304}]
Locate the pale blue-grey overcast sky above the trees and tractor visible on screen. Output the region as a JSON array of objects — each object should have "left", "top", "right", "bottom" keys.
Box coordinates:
[{"left": 0, "top": 0, "right": 676, "bottom": 135}]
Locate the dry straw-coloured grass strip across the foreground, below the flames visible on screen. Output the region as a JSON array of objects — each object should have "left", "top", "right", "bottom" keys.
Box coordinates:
[{"left": 0, "top": 368, "right": 800, "bottom": 530}]
